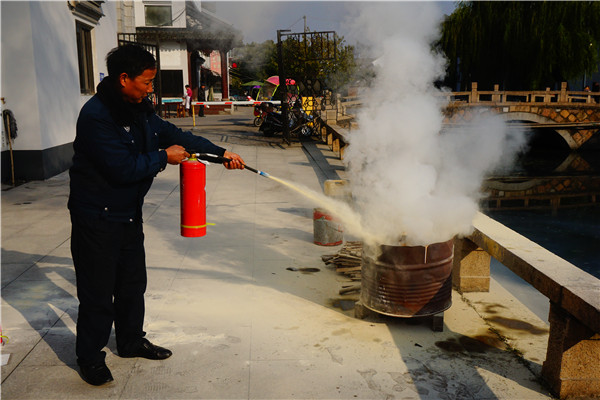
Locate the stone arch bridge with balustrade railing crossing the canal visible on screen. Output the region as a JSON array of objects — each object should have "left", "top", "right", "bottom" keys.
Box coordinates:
[{"left": 444, "top": 82, "right": 600, "bottom": 150}]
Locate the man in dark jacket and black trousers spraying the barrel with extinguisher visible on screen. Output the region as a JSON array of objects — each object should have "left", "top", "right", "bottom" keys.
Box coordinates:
[{"left": 68, "top": 45, "right": 244, "bottom": 385}]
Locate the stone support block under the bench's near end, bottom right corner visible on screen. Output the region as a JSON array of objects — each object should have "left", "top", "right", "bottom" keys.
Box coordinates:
[{"left": 542, "top": 302, "right": 600, "bottom": 399}]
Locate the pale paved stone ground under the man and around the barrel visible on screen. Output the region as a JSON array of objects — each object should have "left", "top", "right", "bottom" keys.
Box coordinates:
[{"left": 1, "top": 109, "right": 551, "bottom": 399}]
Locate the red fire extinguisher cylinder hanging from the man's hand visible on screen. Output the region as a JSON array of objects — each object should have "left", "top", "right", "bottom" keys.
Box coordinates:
[{"left": 179, "top": 155, "right": 206, "bottom": 237}]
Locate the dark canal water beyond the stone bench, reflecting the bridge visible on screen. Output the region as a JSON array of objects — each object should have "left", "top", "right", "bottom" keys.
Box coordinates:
[{"left": 482, "top": 132, "right": 600, "bottom": 321}]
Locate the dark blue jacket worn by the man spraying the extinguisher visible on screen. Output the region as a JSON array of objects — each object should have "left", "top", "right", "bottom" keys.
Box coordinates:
[{"left": 68, "top": 78, "right": 225, "bottom": 222}]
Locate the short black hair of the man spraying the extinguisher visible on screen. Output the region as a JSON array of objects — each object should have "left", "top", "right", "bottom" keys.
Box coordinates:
[{"left": 106, "top": 44, "right": 156, "bottom": 79}]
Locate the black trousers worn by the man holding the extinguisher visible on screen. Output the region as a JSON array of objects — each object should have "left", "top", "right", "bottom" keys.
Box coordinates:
[{"left": 71, "top": 214, "right": 147, "bottom": 364}]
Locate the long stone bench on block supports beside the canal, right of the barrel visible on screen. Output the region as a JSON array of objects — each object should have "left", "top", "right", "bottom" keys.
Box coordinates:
[{"left": 453, "top": 213, "right": 600, "bottom": 399}]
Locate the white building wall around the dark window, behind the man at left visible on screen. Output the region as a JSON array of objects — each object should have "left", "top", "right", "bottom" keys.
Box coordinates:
[{"left": 0, "top": 1, "right": 117, "bottom": 150}]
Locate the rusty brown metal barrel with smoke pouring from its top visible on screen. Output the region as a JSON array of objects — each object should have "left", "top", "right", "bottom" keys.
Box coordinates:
[{"left": 360, "top": 239, "right": 454, "bottom": 317}]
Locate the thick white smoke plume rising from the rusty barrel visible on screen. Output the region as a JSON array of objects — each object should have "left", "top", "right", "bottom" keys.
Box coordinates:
[{"left": 345, "top": 2, "right": 523, "bottom": 245}]
